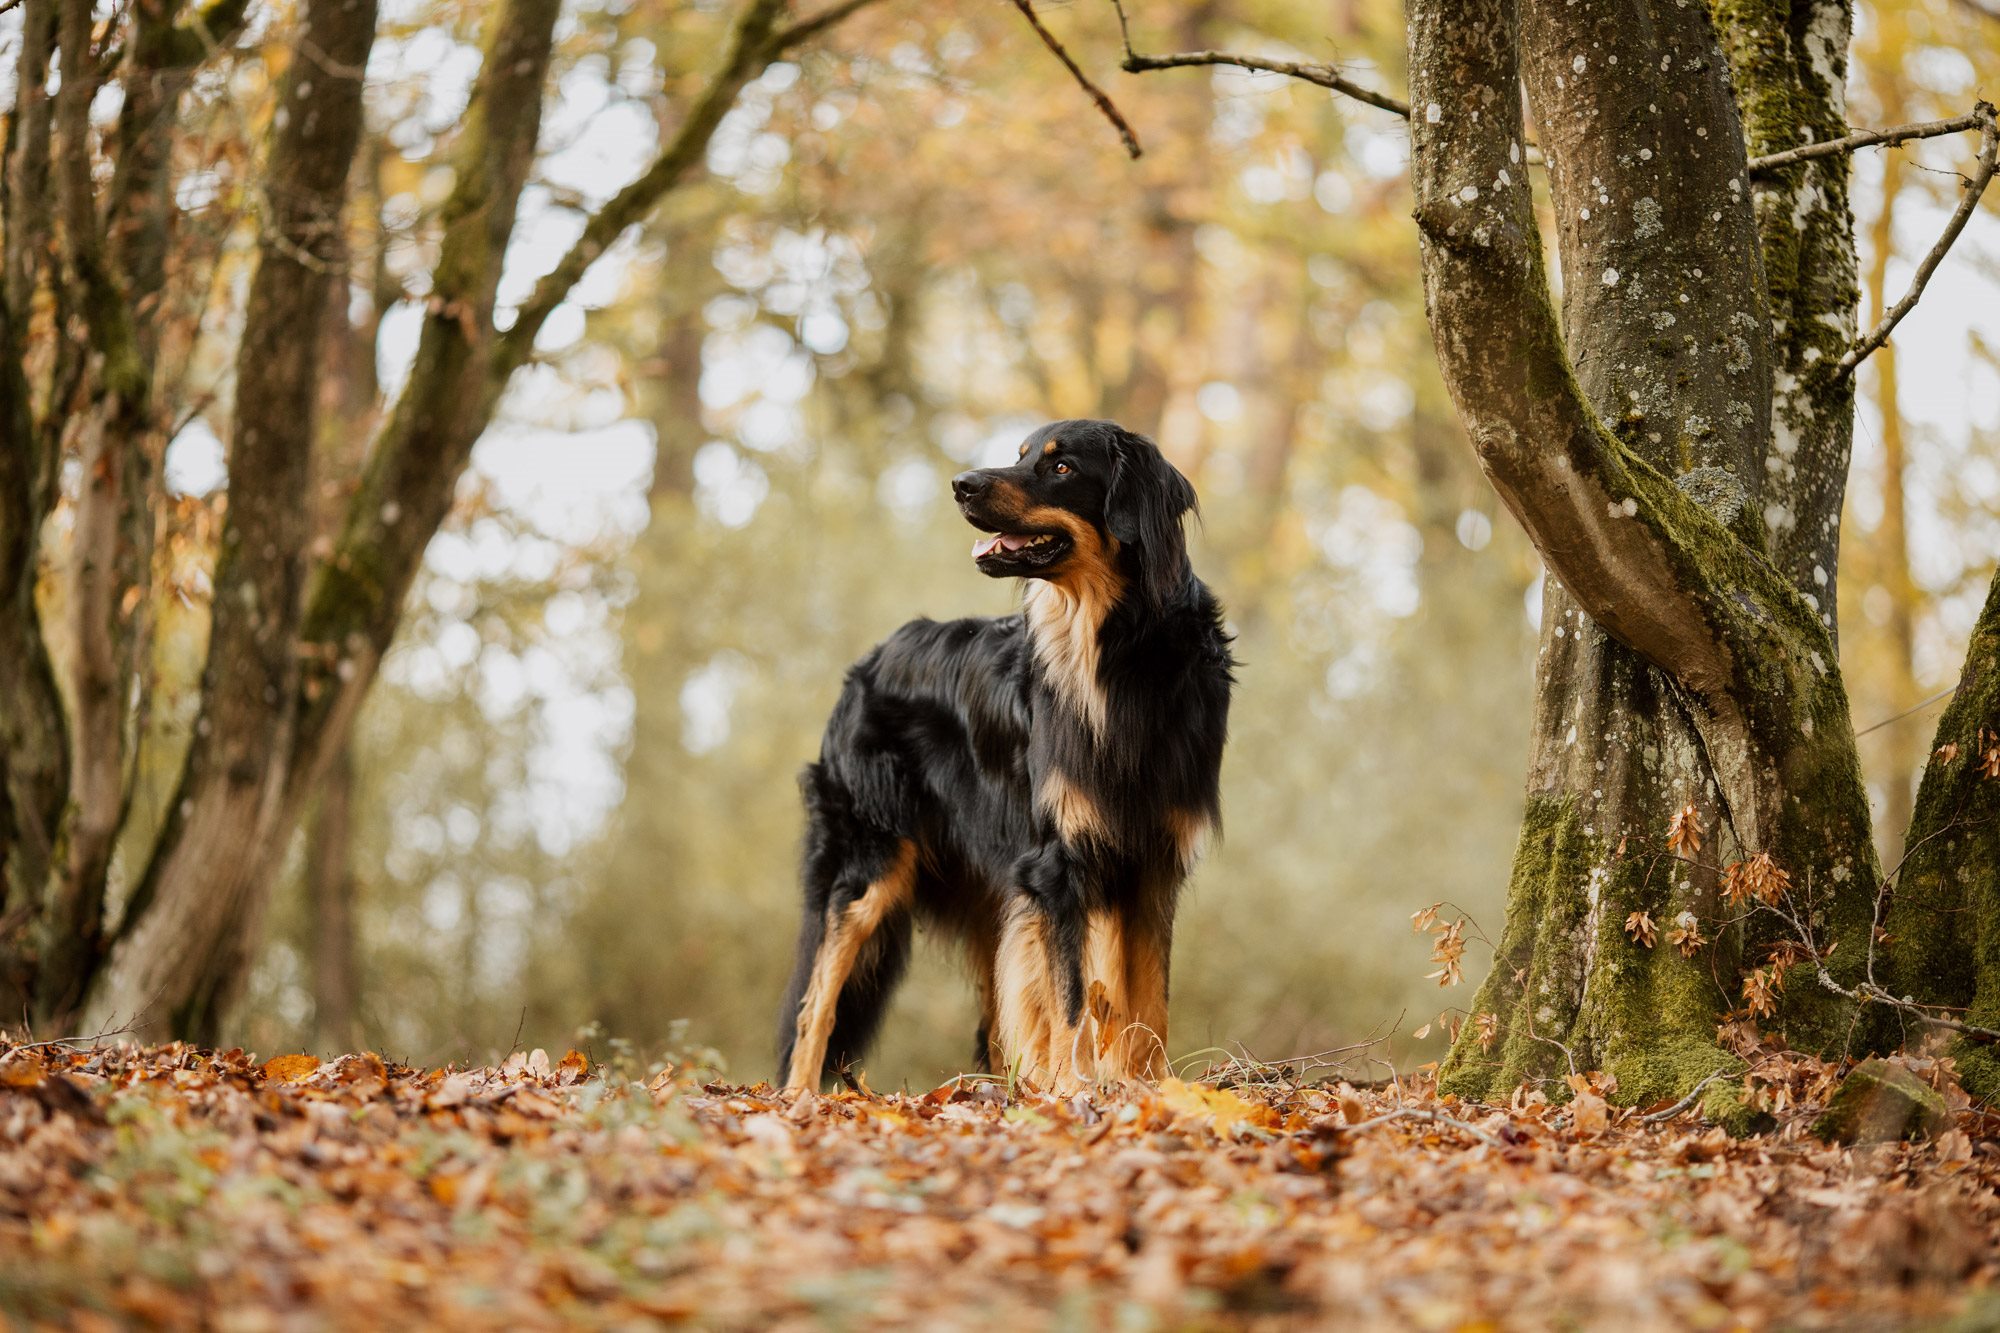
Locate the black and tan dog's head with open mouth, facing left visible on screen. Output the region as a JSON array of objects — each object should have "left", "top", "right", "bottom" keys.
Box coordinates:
[{"left": 952, "top": 420, "right": 1194, "bottom": 606}]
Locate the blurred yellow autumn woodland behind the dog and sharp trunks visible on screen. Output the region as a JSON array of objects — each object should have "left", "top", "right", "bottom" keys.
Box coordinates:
[{"left": 0, "top": 0, "right": 2000, "bottom": 1085}]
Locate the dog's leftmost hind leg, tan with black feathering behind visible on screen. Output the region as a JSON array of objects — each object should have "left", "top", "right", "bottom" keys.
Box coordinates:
[{"left": 784, "top": 839, "right": 916, "bottom": 1089}]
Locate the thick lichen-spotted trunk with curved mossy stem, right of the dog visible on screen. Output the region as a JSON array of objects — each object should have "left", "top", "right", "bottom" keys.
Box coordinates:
[{"left": 1410, "top": 0, "right": 1878, "bottom": 1125}]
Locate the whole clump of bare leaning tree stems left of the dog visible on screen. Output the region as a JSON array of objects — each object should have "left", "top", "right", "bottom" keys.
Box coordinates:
[{"left": 0, "top": 0, "right": 868, "bottom": 1039}]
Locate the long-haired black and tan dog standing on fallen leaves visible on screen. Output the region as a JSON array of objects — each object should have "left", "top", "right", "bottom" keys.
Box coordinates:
[{"left": 778, "top": 420, "right": 1236, "bottom": 1093}]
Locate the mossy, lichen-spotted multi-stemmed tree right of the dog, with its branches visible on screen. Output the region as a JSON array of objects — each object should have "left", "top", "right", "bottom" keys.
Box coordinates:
[{"left": 1124, "top": 0, "right": 2000, "bottom": 1125}]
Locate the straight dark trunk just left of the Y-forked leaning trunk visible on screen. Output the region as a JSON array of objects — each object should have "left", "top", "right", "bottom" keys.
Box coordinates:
[{"left": 92, "top": 0, "right": 376, "bottom": 1041}]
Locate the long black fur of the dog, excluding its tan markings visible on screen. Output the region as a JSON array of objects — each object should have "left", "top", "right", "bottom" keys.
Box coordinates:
[{"left": 778, "top": 420, "right": 1234, "bottom": 1079}]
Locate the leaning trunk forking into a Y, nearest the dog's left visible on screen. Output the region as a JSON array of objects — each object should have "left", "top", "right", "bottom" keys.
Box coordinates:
[{"left": 86, "top": 0, "right": 868, "bottom": 1039}]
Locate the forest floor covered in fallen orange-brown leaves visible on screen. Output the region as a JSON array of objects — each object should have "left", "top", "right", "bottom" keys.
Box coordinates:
[{"left": 0, "top": 1041, "right": 2000, "bottom": 1329}]
